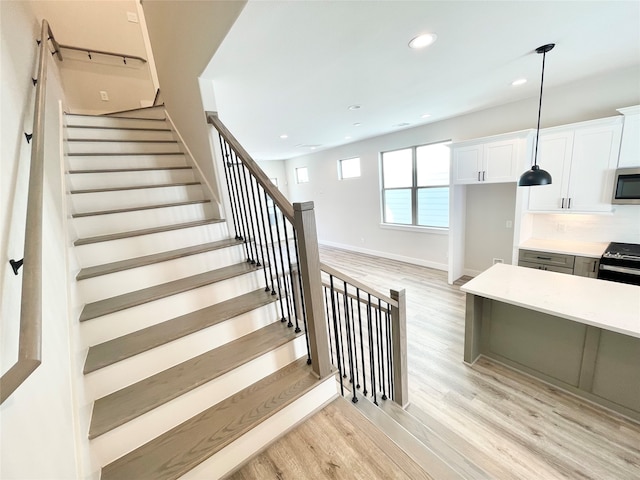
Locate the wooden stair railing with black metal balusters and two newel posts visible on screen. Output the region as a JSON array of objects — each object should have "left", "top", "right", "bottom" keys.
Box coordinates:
[{"left": 207, "top": 112, "right": 408, "bottom": 406}]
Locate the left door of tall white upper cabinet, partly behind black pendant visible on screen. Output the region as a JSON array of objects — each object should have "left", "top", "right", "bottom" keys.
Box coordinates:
[{"left": 529, "top": 131, "right": 573, "bottom": 211}]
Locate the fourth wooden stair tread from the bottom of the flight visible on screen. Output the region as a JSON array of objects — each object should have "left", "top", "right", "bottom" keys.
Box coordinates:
[{"left": 80, "top": 262, "right": 257, "bottom": 322}]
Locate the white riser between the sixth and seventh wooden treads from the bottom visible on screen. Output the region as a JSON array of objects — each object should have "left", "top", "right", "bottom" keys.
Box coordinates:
[{"left": 73, "top": 202, "right": 213, "bottom": 238}]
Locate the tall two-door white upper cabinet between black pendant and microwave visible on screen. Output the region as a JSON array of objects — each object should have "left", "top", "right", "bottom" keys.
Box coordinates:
[{"left": 529, "top": 117, "right": 622, "bottom": 213}]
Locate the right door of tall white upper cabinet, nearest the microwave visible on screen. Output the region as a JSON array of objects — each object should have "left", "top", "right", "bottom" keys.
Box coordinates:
[{"left": 567, "top": 124, "right": 621, "bottom": 212}]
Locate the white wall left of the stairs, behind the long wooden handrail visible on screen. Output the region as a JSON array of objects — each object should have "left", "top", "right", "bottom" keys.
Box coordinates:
[{"left": 0, "top": 1, "right": 88, "bottom": 480}]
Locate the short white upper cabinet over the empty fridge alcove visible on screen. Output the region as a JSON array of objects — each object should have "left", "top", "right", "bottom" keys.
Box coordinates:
[{"left": 451, "top": 131, "right": 531, "bottom": 185}]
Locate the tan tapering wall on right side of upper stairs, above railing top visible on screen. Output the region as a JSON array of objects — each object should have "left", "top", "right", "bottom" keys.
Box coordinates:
[{"left": 142, "top": 0, "right": 245, "bottom": 219}]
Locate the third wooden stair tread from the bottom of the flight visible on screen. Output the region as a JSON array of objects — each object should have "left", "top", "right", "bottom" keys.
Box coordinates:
[{"left": 84, "top": 289, "right": 278, "bottom": 374}]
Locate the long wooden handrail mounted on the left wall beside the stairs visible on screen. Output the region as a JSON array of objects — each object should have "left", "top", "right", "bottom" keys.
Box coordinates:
[{"left": 0, "top": 20, "right": 53, "bottom": 403}]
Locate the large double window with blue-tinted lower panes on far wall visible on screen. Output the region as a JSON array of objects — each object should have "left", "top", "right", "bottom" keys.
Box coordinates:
[{"left": 381, "top": 142, "right": 451, "bottom": 228}]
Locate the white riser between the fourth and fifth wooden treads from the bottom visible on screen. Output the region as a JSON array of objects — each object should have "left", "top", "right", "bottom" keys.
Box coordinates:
[{"left": 78, "top": 246, "right": 245, "bottom": 303}]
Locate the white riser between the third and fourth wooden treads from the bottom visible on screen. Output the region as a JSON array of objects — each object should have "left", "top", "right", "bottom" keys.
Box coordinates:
[{"left": 80, "top": 270, "right": 264, "bottom": 347}]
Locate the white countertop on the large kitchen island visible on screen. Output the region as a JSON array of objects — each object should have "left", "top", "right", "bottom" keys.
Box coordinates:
[{"left": 460, "top": 264, "right": 640, "bottom": 338}]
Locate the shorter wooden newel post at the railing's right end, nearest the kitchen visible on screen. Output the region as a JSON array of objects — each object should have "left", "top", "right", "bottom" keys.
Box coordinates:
[{"left": 390, "top": 290, "right": 409, "bottom": 408}]
